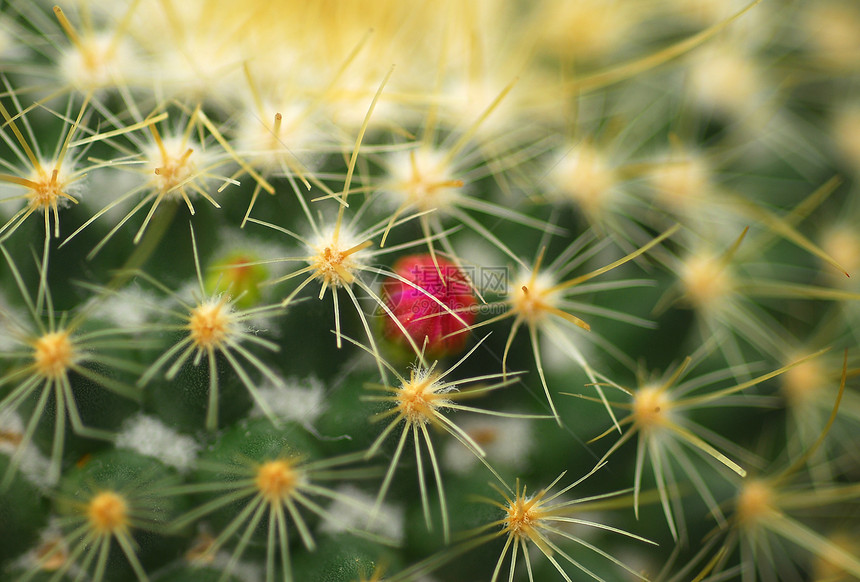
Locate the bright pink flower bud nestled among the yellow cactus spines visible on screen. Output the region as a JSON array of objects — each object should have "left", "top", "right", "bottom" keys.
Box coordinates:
[{"left": 382, "top": 253, "right": 477, "bottom": 360}]
